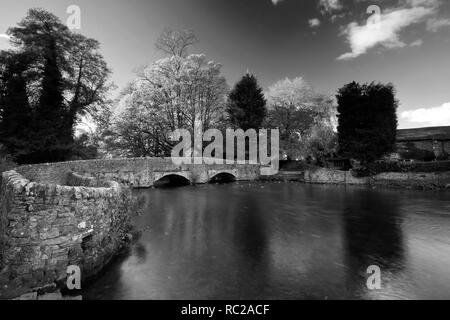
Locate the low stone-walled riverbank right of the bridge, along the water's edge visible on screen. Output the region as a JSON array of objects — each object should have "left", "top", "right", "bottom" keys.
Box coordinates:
[{"left": 262, "top": 168, "right": 450, "bottom": 190}]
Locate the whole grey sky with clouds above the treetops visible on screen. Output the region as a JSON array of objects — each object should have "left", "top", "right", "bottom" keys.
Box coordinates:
[{"left": 0, "top": 0, "right": 450, "bottom": 128}]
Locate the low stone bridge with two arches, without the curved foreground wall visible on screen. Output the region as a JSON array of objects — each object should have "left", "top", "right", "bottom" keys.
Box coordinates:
[{"left": 16, "top": 158, "right": 261, "bottom": 188}]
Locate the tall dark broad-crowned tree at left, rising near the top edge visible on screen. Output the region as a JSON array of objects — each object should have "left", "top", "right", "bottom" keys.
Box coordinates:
[{"left": 0, "top": 9, "right": 111, "bottom": 163}]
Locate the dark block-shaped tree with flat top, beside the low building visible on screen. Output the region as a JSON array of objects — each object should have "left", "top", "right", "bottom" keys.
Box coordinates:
[{"left": 336, "top": 82, "right": 398, "bottom": 165}]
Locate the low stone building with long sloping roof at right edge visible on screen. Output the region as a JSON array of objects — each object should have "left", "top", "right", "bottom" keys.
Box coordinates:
[{"left": 397, "top": 126, "right": 450, "bottom": 160}]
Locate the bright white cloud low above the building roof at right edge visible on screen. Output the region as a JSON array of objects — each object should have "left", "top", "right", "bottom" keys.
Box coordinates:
[{"left": 400, "top": 102, "right": 450, "bottom": 126}]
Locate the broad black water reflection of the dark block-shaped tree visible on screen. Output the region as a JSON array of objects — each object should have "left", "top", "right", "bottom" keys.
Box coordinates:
[{"left": 343, "top": 190, "right": 405, "bottom": 296}]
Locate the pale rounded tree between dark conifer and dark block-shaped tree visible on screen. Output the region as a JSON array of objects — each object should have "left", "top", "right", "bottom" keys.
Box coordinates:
[{"left": 266, "top": 77, "right": 335, "bottom": 160}]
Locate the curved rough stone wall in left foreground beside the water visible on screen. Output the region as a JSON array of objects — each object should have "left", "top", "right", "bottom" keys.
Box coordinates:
[{"left": 0, "top": 167, "right": 132, "bottom": 298}]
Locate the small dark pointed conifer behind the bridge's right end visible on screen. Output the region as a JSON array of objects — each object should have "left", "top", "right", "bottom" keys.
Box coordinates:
[{"left": 226, "top": 73, "right": 267, "bottom": 131}]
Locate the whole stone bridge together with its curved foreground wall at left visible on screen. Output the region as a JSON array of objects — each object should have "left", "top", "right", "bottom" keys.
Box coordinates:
[{"left": 0, "top": 158, "right": 260, "bottom": 298}]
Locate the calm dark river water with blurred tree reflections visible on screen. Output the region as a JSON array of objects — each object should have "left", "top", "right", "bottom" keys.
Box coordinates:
[{"left": 83, "top": 182, "right": 450, "bottom": 299}]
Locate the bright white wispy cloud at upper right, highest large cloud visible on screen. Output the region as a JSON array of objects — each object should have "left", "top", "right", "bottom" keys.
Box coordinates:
[{"left": 338, "top": 4, "right": 436, "bottom": 60}]
